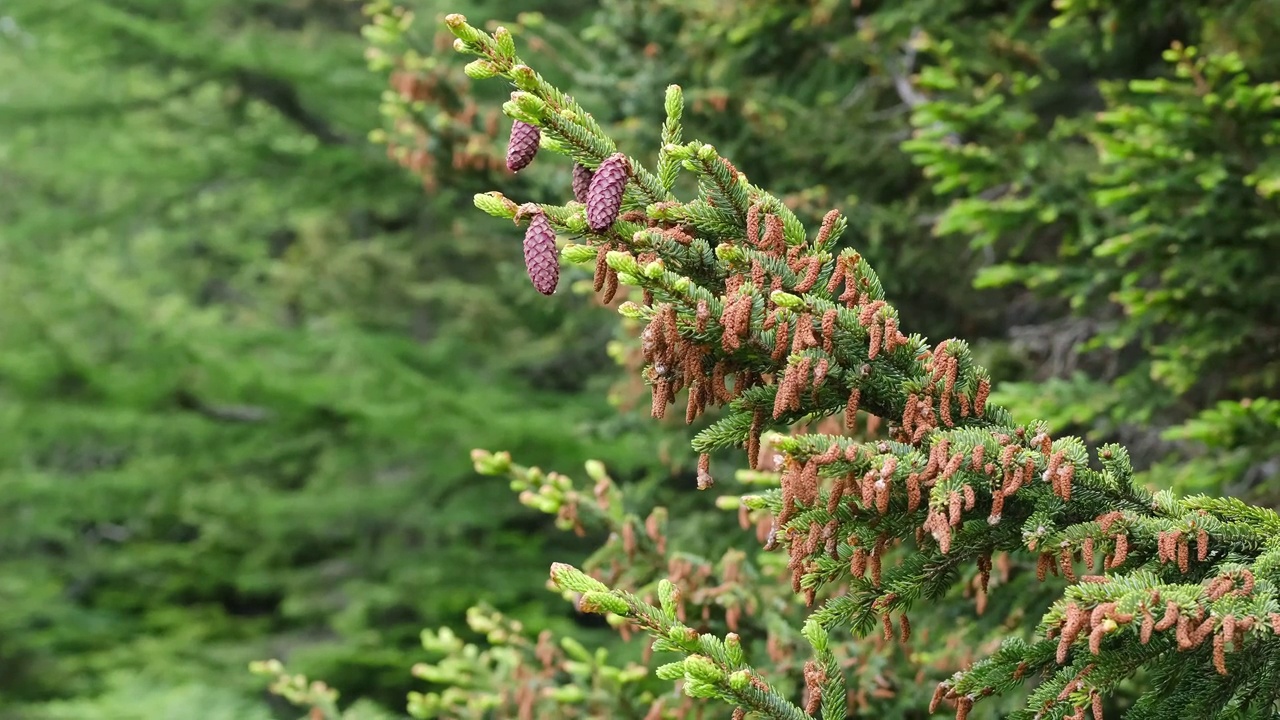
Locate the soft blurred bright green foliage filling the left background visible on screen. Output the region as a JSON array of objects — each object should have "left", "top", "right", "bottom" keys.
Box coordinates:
[{"left": 0, "top": 0, "right": 653, "bottom": 715}]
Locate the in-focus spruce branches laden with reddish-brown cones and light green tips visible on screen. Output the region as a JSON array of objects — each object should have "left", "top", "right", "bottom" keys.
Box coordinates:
[{"left": 437, "top": 15, "right": 1280, "bottom": 720}]
